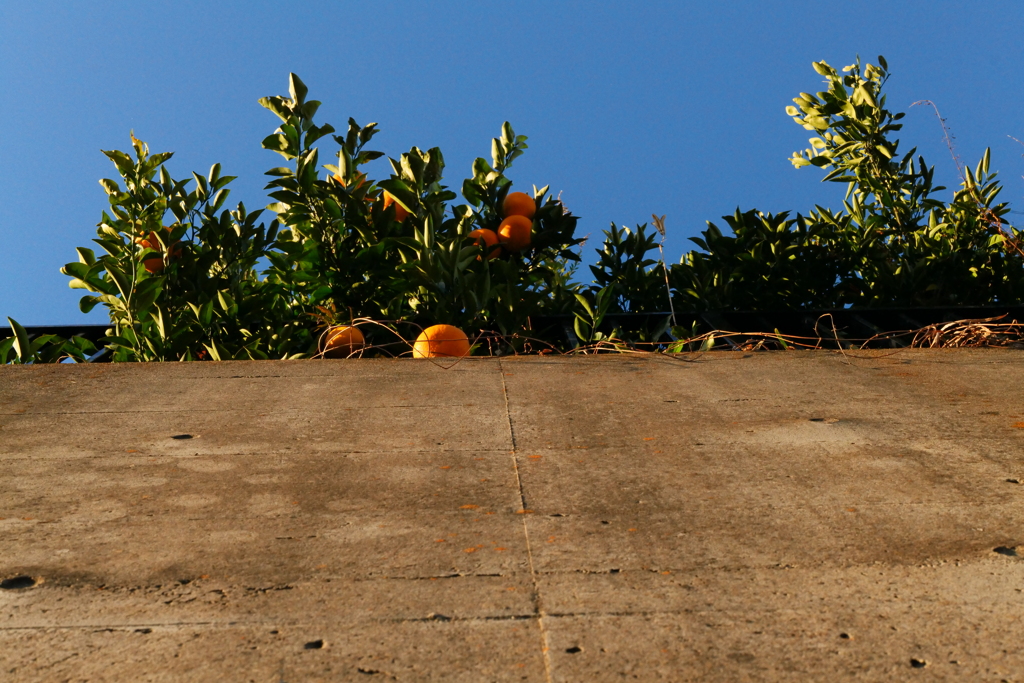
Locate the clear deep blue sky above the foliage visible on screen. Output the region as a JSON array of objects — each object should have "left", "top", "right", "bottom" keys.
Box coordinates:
[{"left": 0, "top": 0, "right": 1024, "bottom": 325}]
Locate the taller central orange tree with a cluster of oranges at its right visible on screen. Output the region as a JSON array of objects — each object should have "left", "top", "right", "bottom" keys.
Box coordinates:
[{"left": 260, "top": 74, "right": 582, "bottom": 348}]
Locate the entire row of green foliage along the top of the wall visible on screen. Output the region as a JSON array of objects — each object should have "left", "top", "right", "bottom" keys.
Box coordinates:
[{"left": 0, "top": 57, "right": 1024, "bottom": 364}]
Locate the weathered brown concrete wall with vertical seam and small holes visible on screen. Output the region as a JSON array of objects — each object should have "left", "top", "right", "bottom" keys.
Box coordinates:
[{"left": 0, "top": 350, "right": 1024, "bottom": 683}]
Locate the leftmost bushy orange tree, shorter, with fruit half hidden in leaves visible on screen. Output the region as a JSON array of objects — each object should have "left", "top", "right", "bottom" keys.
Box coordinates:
[{"left": 61, "top": 136, "right": 294, "bottom": 360}]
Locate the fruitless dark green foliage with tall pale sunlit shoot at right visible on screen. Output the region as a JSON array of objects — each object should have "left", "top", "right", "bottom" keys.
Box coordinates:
[{"left": 672, "top": 57, "right": 1024, "bottom": 309}]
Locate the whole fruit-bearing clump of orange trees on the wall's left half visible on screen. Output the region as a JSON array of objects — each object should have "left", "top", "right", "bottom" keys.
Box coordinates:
[{"left": 25, "top": 74, "right": 582, "bottom": 362}]
